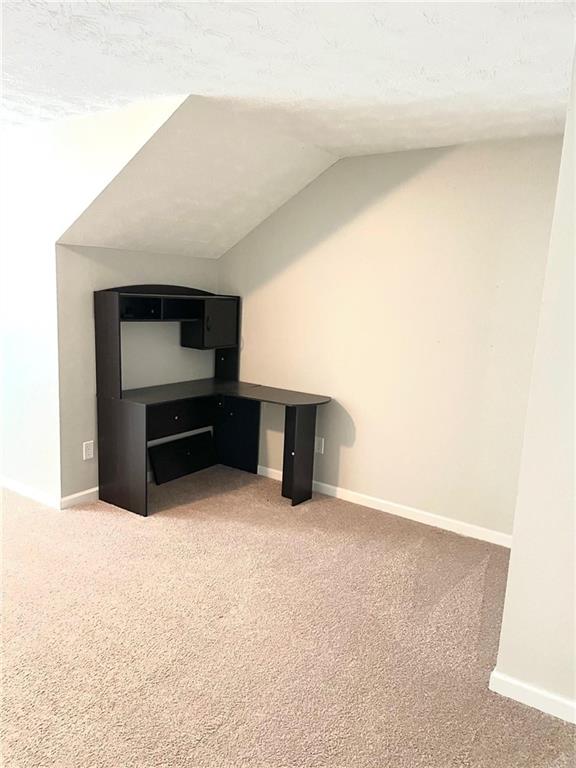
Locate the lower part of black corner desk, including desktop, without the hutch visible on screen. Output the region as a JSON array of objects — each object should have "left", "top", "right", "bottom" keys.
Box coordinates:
[{"left": 98, "top": 379, "right": 330, "bottom": 515}]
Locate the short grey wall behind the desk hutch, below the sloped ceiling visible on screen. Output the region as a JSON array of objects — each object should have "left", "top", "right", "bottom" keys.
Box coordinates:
[{"left": 57, "top": 245, "right": 217, "bottom": 496}]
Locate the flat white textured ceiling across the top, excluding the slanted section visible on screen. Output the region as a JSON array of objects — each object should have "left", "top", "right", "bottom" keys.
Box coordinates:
[{"left": 3, "top": 0, "right": 574, "bottom": 156}]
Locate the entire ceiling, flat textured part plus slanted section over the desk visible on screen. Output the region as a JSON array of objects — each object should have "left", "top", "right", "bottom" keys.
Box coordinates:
[{"left": 3, "top": 0, "right": 574, "bottom": 258}]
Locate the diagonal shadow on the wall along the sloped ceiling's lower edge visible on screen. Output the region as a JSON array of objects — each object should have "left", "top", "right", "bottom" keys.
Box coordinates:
[{"left": 221, "top": 147, "right": 454, "bottom": 298}]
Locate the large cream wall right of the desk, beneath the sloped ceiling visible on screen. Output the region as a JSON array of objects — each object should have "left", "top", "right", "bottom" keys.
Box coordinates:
[{"left": 219, "top": 138, "right": 560, "bottom": 533}]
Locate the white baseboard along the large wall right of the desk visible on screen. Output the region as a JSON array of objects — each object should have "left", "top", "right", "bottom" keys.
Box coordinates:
[{"left": 258, "top": 466, "right": 512, "bottom": 549}]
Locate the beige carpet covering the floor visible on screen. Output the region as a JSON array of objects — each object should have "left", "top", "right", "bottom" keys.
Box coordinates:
[{"left": 3, "top": 467, "right": 574, "bottom": 768}]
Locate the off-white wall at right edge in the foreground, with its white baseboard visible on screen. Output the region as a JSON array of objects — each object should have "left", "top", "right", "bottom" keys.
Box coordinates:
[{"left": 490, "top": 69, "right": 576, "bottom": 722}]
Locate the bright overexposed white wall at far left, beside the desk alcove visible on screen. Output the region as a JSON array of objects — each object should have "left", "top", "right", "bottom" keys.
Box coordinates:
[{"left": 0, "top": 99, "right": 182, "bottom": 504}]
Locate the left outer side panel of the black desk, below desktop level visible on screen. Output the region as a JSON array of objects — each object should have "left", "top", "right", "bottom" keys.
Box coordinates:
[{"left": 98, "top": 397, "right": 148, "bottom": 516}]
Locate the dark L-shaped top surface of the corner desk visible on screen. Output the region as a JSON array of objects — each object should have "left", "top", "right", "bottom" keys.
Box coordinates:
[{"left": 122, "top": 379, "right": 330, "bottom": 405}]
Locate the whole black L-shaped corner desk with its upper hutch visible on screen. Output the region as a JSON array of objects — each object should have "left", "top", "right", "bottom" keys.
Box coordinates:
[{"left": 94, "top": 285, "right": 330, "bottom": 516}]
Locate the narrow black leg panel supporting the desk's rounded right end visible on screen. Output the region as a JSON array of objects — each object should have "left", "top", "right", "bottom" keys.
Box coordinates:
[{"left": 282, "top": 405, "right": 316, "bottom": 506}]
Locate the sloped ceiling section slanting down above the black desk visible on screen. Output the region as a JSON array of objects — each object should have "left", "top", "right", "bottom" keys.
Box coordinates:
[{"left": 59, "top": 97, "right": 337, "bottom": 258}]
